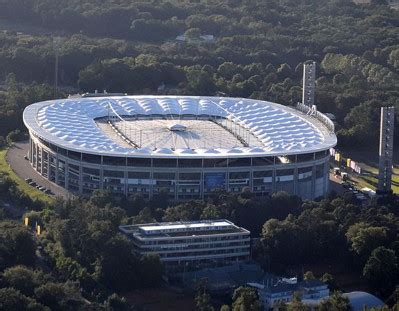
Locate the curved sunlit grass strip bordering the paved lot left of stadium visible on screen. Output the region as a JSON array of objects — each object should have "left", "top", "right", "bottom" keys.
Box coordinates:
[{"left": 0, "top": 149, "right": 54, "bottom": 203}]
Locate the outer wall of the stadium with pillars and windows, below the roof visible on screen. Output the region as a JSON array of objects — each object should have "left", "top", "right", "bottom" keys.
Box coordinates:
[{"left": 29, "top": 136, "right": 329, "bottom": 200}]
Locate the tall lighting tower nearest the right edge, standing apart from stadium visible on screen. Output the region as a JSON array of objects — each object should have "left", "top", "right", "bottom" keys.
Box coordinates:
[{"left": 377, "top": 107, "right": 395, "bottom": 195}]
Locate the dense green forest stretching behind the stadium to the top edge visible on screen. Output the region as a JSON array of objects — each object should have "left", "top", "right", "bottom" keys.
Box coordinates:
[{"left": 0, "top": 0, "right": 399, "bottom": 147}]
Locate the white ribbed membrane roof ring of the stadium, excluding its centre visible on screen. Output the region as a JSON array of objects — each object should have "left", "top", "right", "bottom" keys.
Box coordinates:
[{"left": 23, "top": 95, "right": 337, "bottom": 158}]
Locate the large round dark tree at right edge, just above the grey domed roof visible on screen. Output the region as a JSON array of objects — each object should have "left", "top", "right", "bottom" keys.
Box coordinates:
[{"left": 363, "top": 246, "right": 399, "bottom": 296}]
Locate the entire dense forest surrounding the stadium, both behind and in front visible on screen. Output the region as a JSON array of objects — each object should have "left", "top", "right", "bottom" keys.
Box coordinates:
[{"left": 0, "top": 0, "right": 399, "bottom": 310}]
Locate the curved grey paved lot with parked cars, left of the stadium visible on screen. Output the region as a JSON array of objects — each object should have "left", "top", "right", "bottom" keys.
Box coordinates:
[{"left": 7, "top": 142, "right": 73, "bottom": 199}]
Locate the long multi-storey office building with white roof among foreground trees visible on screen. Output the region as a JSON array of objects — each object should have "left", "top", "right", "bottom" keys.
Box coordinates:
[{"left": 119, "top": 220, "right": 250, "bottom": 270}]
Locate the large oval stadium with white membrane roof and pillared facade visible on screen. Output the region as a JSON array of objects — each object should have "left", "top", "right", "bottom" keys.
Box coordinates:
[{"left": 23, "top": 95, "right": 337, "bottom": 201}]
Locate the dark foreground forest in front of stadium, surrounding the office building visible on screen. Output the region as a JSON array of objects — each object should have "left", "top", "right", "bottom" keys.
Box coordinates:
[{"left": 0, "top": 176, "right": 399, "bottom": 310}]
